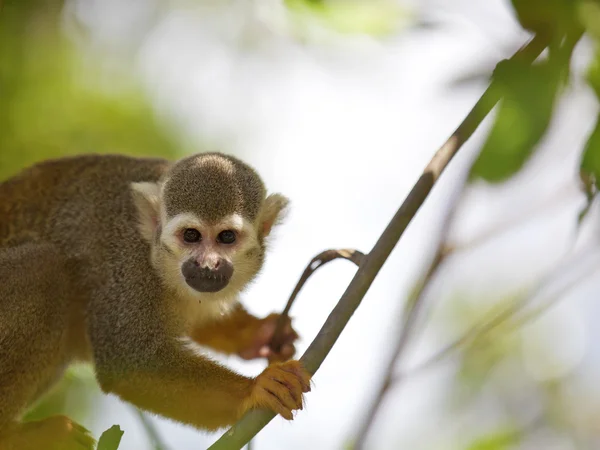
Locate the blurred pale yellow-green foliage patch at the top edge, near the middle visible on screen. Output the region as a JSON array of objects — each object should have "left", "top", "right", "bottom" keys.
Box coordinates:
[{"left": 285, "top": 0, "right": 404, "bottom": 36}]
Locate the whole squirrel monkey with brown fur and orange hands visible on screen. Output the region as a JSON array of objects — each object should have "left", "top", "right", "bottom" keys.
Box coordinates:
[{"left": 0, "top": 153, "right": 310, "bottom": 450}]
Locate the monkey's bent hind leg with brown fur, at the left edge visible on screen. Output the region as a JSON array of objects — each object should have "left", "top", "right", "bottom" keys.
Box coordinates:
[{"left": 0, "top": 244, "right": 94, "bottom": 450}]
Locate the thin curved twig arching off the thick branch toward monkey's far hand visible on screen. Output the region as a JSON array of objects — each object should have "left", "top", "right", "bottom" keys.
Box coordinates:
[{"left": 269, "top": 248, "right": 365, "bottom": 352}]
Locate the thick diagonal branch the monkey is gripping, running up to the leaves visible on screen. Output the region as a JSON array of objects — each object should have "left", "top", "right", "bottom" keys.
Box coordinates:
[{"left": 209, "top": 36, "right": 546, "bottom": 450}]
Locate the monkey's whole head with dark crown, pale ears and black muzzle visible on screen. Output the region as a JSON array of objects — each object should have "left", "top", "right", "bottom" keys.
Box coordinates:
[{"left": 132, "top": 153, "right": 288, "bottom": 299}]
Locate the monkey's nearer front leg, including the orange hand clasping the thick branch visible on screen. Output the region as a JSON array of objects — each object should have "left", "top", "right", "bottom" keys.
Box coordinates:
[{"left": 96, "top": 342, "right": 310, "bottom": 430}]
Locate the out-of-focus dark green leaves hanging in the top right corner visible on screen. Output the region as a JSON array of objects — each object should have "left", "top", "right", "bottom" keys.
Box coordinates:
[{"left": 471, "top": 0, "right": 600, "bottom": 185}]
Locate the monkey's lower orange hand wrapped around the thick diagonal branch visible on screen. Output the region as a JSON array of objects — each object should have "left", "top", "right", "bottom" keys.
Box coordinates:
[{"left": 243, "top": 361, "right": 311, "bottom": 420}]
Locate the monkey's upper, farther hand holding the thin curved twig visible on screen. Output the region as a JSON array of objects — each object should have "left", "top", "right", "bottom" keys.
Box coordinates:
[{"left": 238, "top": 313, "right": 298, "bottom": 362}]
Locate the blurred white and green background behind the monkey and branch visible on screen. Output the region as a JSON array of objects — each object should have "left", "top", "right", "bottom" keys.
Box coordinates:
[{"left": 0, "top": 0, "right": 600, "bottom": 450}]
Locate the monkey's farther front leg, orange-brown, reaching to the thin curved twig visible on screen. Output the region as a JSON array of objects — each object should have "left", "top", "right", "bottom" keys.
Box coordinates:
[{"left": 190, "top": 304, "right": 298, "bottom": 361}]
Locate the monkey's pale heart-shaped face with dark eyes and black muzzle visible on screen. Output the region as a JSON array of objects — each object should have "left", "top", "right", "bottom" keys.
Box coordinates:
[{"left": 155, "top": 213, "right": 263, "bottom": 294}]
